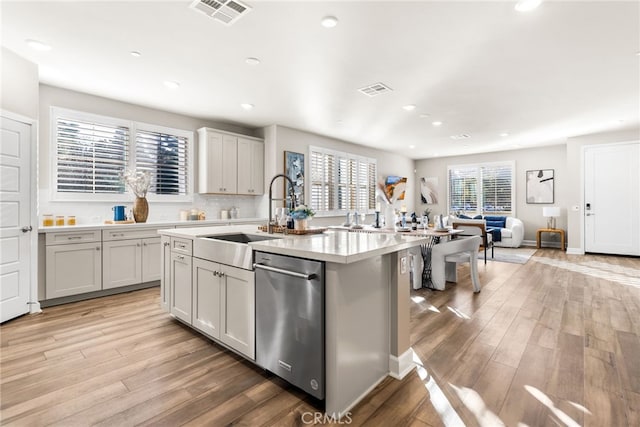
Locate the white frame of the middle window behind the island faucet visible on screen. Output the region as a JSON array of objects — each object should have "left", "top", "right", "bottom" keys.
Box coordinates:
[{"left": 306, "top": 145, "right": 378, "bottom": 217}]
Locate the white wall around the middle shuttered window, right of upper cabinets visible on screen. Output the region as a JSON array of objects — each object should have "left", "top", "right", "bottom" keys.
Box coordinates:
[{"left": 265, "top": 125, "right": 415, "bottom": 225}]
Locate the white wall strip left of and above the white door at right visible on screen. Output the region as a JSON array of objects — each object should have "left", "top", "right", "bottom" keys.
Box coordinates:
[{"left": 566, "top": 128, "right": 640, "bottom": 254}]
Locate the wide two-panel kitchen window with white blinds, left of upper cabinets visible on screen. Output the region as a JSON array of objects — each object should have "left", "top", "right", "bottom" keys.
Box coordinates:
[{"left": 51, "top": 107, "right": 193, "bottom": 201}]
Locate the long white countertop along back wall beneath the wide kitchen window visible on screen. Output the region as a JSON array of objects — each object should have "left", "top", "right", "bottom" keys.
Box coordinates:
[{"left": 38, "top": 218, "right": 268, "bottom": 233}]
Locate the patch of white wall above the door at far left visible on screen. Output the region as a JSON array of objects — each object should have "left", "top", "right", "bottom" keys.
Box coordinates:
[{"left": 0, "top": 47, "right": 38, "bottom": 120}]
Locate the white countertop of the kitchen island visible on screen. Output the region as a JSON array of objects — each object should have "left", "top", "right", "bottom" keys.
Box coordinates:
[{"left": 159, "top": 225, "right": 430, "bottom": 264}]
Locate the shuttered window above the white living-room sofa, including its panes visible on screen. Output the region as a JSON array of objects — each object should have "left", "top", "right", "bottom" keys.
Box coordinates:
[{"left": 448, "top": 162, "right": 515, "bottom": 216}]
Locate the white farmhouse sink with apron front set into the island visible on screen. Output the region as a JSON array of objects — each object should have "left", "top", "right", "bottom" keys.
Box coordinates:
[{"left": 193, "top": 233, "right": 282, "bottom": 270}]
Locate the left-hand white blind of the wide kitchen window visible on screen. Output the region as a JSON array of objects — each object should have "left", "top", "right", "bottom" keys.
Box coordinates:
[{"left": 55, "top": 117, "right": 129, "bottom": 194}]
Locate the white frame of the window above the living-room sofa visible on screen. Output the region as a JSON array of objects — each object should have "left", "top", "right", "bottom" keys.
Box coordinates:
[{"left": 447, "top": 160, "right": 516, "bottom": 217}]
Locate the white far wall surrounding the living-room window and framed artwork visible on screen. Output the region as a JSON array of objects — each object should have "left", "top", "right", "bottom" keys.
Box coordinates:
[{"left": 414, "top": 145, "right": 570, "bottom": 244}]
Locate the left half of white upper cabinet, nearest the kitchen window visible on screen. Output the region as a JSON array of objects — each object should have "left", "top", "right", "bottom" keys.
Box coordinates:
[{"left": 198, "top": 129, "right": 238, "bottom": 194}]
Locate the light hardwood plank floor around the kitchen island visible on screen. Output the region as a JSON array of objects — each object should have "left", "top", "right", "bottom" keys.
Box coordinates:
[{"left": 0, "top": 249, "right": 640, "bottom": 427}]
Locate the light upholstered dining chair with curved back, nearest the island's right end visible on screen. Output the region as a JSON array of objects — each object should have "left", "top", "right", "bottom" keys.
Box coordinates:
[{"left": 431, "top": 236, "right": 482, "bottom": 293}]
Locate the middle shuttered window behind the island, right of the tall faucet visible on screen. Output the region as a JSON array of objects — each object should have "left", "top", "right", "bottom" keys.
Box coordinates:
[{"left": 309, "top": 147, "right": 377, "bottom": 214}]
